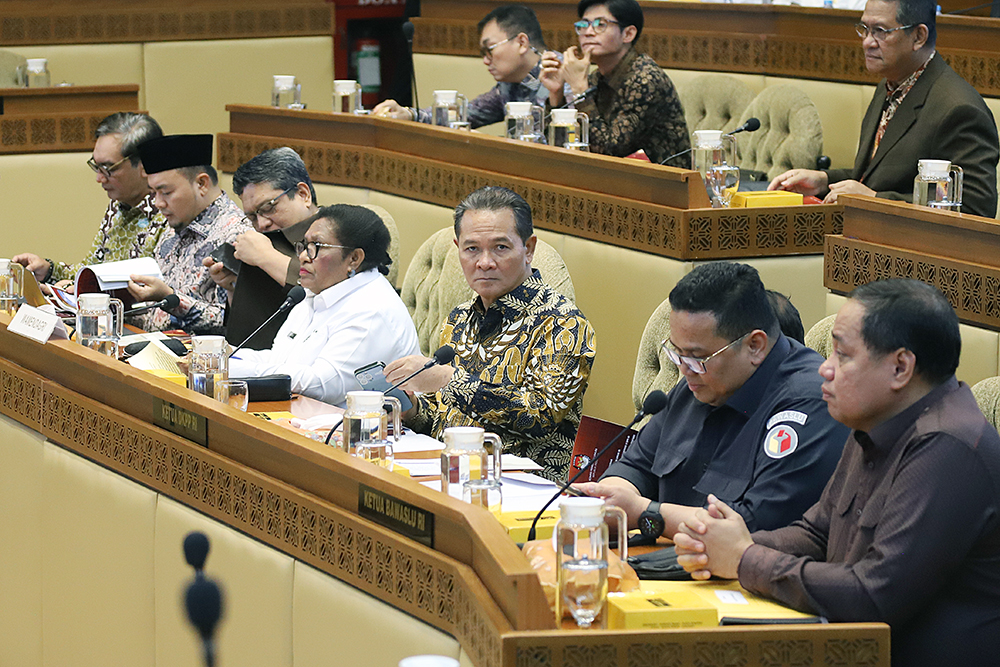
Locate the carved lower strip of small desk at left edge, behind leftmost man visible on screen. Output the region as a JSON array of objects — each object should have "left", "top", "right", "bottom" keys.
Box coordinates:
[{"left": 0, "top": 111, "right": 109, "bottom": 154}]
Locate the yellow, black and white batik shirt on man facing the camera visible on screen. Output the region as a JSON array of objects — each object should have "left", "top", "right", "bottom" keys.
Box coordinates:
[{"left": 410, "top": 271, "right": 596, "bottom": 481}]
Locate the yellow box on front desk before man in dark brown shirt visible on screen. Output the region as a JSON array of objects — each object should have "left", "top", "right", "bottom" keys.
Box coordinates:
[{"left": 608, "top": 590, "right": 719, "bottom": 630}]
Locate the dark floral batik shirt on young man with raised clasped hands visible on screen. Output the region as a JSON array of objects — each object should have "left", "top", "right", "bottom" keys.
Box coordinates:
[{"left": 575, "top": 49, "right": 691, "bottom": 169}]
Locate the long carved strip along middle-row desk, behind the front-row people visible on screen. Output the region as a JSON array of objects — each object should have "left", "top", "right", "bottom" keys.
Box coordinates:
[{"left": 217, "top": 134, "right": 843, "bottom": 259}]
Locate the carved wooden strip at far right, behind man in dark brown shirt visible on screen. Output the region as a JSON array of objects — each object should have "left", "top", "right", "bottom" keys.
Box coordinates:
[{"left": 823, "top": 236, "right": 1000, "bottom": 329}]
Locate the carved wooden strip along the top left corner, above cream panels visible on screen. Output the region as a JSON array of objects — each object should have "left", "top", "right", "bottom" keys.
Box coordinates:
[{"left": 0, "top": 0, "right": 333, "bottom": 46}]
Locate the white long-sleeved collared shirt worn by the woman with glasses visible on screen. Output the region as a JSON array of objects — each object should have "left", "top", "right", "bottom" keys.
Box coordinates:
[{"left": 229, "top": 269, "right": 420, "bottom": 406}]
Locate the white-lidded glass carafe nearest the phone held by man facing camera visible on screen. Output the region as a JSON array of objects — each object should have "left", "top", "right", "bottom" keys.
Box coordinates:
[{"left": 342, "top": 391, "right": 402, "bottom": 467}]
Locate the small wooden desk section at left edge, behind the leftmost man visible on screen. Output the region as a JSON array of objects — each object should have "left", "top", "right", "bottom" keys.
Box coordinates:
[{"left": 0, "top": 84, "right": 139, "bottom": 154}]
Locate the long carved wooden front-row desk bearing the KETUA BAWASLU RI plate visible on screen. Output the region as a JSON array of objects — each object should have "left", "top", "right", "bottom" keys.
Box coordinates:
[{"left": 0, "top": 315, "right": 889, "bottom": 667}]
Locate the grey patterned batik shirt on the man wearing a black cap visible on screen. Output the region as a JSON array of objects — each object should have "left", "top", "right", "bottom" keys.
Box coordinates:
[{"left": 136, "top": 193, "right": 252, "bottom": 334}]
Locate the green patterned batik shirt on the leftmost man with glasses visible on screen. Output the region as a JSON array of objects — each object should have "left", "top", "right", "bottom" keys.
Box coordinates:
[{"left": 49, "top": 194, "right": 167, "bottom": 282}]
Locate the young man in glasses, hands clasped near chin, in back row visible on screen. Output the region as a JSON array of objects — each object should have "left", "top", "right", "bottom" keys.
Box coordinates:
[{"left": 541, "top": 0, "right": 691, "bottom": 169}]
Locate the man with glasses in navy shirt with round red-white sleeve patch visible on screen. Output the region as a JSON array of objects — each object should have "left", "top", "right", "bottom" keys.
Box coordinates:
[{"left": 578, "top": 262, "right": 848, "bottom": 538}]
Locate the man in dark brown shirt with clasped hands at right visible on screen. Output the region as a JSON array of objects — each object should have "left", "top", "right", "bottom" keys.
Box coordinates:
[{"left": 674, "top": 280, "right": 1000, "bottom": 667}]
